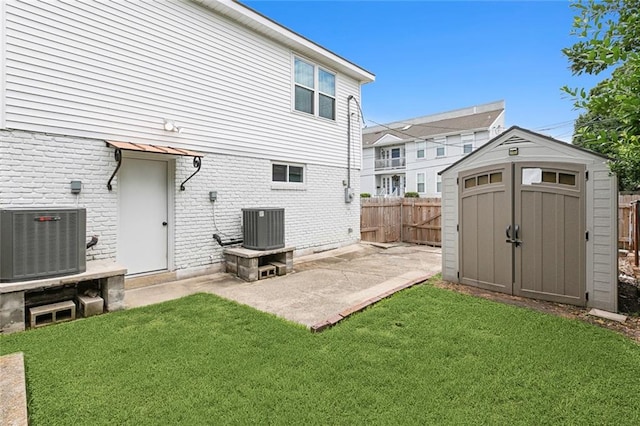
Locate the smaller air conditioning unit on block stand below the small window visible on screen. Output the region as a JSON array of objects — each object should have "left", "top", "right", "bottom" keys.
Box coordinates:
[{"left": 242, "top": 208, "right": 284, "bottom": 250}]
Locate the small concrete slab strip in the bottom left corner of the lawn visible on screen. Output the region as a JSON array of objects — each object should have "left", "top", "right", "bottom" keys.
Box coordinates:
[{"left": 0, "top": 352, "right": 29, "bottom": 426}]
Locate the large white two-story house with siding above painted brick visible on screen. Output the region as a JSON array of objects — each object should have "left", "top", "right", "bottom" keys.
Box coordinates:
[{"left": 0, "top": 0, "right": 374, "bottom": 278}]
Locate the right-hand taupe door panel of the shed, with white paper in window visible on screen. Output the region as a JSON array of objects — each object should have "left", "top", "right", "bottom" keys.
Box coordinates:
[{"left": 514, "top": 163, "right": 585, "bottom": 305}]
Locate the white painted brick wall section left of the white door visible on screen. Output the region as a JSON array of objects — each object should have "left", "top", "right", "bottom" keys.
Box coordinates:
[{"left": 0, "top": 130, "right": 118, "bottom": 260}]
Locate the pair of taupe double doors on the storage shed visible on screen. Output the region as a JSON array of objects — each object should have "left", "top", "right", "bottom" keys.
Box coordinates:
[{"left": 458, "top": 162, "right": 585, "bottom": 305}]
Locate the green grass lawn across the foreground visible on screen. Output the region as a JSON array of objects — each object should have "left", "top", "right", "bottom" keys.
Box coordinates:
[{"left": 0, "top": 285, "right": 640, "bottom": 425}]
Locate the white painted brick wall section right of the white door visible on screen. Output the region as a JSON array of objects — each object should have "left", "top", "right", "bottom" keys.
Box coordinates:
[{"left": 175, "top": 154, "right": 360, "bottom": 269}]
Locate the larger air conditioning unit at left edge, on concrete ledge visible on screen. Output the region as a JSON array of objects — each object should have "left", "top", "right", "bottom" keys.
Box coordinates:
[{"left": 0, "top": 208, "right": 87, "bottom": 282}]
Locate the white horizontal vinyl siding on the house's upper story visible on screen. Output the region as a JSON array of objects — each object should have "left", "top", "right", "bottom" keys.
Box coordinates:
[{"left": 3, "top": 1, "right": 361, "bottom": 168}]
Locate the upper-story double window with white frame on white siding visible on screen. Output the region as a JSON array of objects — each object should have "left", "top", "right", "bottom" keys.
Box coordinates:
[{"left": 293, "top": 58, "right": 336, "bottom": 120}]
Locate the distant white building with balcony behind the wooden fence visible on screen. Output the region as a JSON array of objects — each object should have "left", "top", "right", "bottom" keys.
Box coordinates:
[{"left": 360, "top": 101, "right": 505, "bottom": 197}]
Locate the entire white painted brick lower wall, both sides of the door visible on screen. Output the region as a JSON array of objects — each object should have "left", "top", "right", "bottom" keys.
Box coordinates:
[{"left": 0, "top": 130, "right": 360, "bottom": 275}]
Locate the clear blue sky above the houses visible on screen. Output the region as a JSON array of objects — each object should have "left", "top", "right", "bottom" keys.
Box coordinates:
[{"left": 244, "top": 0, "right": 604, "bottom": 140}]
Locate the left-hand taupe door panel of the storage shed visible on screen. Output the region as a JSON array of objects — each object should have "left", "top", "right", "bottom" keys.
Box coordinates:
[{"left": 459, "top": 166, "right": 512, "bottom": 293}]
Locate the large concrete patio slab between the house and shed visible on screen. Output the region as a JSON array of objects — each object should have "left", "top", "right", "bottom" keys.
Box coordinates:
[{"left": 125, "top": 244, "right": 441, "bottom": 328}]
